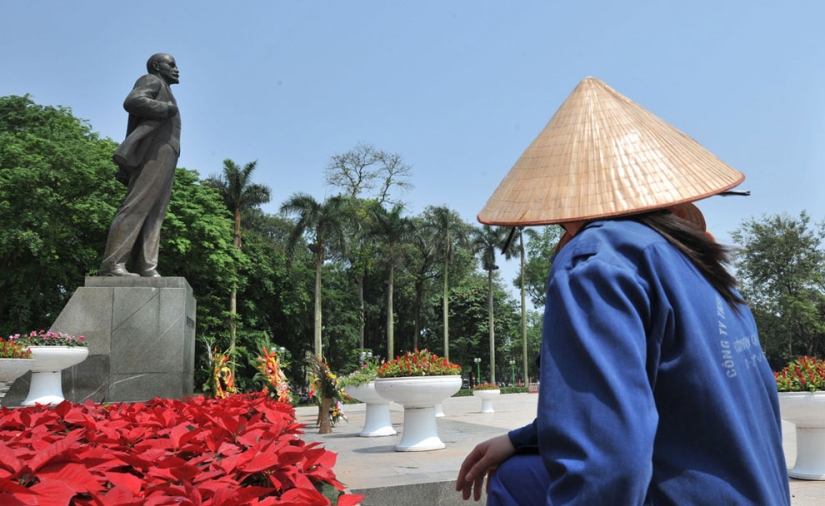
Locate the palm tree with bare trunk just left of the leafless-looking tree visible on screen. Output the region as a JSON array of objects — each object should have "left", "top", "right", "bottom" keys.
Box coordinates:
[{"left": 281, "top": 192, "right": 346, "bottom": 358}]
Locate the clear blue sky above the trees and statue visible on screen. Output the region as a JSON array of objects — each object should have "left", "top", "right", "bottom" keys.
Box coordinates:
[{"left": 0, "top": 0, "right": 825, "bottom": 292}]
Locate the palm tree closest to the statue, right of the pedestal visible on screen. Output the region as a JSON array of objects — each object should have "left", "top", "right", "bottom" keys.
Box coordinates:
[{"left": 206, "top": 158, "right": 271, "bottom": 362}]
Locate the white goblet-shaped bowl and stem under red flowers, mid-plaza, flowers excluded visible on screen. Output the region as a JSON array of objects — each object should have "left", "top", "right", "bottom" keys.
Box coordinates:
[{"left": 375, "top": 374, "right": 461, "bottom": 452}]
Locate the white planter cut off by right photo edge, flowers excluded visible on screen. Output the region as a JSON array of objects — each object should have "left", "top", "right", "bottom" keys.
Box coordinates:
[{"left": 779, "top": 392, "right": 825, "bottom": 480}]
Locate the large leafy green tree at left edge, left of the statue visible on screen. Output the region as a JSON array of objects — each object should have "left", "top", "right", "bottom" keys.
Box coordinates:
[{"left": 0, "top": 95, "right": 125, "bottom": 335}]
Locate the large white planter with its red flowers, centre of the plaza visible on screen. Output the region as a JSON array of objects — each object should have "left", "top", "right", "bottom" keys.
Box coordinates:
[{"left": 375, "top": 349, "right": 461, "bottom": 452}]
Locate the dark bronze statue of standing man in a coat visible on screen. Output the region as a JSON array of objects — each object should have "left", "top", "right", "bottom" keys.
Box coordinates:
[{"left": 100, "top": 53, "right": 181, "bottom": 277}]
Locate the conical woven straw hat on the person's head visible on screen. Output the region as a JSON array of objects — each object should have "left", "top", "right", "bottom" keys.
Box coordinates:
[{"left": 478, "top": 77, "right": 745, "bottom": 226}]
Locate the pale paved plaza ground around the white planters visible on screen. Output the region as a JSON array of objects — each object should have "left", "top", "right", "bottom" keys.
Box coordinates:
[{"left": 296, "top": 394, "right": 825, "bottom": 506}]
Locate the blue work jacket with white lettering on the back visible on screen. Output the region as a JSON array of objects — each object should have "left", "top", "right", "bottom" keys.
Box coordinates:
[{"left": 510, "top": 220, "right": 790, "bottom": 506}]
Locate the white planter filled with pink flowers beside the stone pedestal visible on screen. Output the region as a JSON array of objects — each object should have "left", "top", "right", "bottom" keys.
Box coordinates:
[{"left": 9, "top": 330, "right": 89, "bottom": 406}]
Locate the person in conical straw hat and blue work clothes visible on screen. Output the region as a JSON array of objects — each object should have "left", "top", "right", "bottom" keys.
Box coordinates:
[{"left": 456, "top": 78, "right": 790, "bottom": 506}]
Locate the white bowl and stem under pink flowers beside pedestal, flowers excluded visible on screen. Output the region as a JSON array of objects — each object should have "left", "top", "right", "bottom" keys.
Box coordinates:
[{"left": 22, "top": 346, "right": 89, "bottom": 406}]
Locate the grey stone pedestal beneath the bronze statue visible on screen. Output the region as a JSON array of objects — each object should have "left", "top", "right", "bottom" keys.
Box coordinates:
[{"left": 3, "top": 277, "right": 196, "bottom": 406}]
